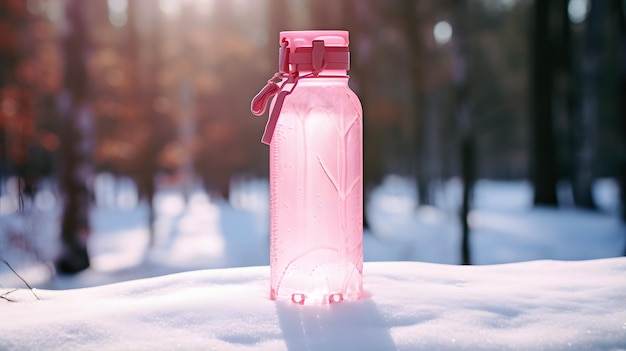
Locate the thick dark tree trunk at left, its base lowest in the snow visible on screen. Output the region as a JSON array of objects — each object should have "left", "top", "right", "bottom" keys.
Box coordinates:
[{"left": 56, "top": 0, "right": 92, "bottom": 274}]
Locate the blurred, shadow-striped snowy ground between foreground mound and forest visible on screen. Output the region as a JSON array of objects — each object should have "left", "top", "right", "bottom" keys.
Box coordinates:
[{"left": 0, "top": 174, "right": 626, "bottom": 289}]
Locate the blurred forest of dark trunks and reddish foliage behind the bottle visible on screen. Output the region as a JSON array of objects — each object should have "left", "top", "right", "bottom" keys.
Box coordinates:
[{"left": 0, "top": 0, "right": 626, "bottom": 272}]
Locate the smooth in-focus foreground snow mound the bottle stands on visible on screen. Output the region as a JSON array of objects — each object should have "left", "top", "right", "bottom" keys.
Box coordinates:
[{"left": 0, "top": 258, "right": 626, "bottom": 350}]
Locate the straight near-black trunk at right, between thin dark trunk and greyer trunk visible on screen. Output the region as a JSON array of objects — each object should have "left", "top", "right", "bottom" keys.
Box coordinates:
[{"left": 531, "top": 1, "right": 558, "bottom": 206}]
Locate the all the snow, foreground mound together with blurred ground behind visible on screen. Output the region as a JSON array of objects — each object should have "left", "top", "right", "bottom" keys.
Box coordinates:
[{"left": 0, "top": 176, "right": 626, "bottom": 350}]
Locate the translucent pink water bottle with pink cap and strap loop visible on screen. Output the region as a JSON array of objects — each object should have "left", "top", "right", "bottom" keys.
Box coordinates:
[{"left": 252, "top": 31, "right": 363, "bottom": 305}]
